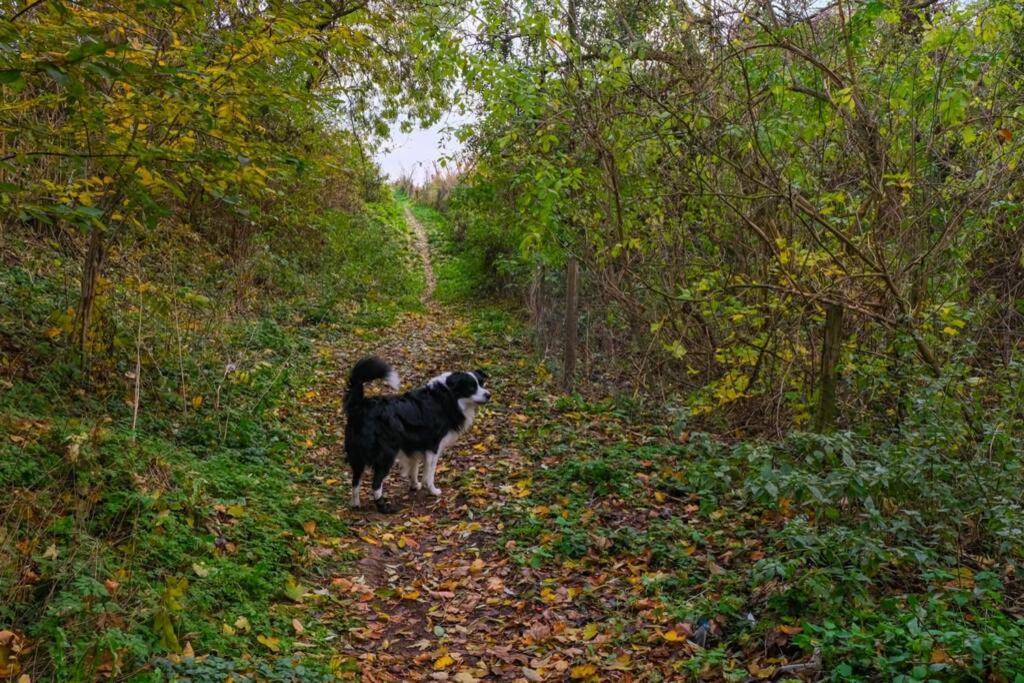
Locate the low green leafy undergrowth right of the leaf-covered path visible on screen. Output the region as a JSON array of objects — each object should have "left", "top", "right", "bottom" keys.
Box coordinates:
[{"left": 501, "top": 385, "right": 1024, "bottom": 681}]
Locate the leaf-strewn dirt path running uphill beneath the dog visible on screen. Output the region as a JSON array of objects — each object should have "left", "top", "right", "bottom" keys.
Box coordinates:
[{"left": 301, "top": 208, "right": 548, "bottom": 681}]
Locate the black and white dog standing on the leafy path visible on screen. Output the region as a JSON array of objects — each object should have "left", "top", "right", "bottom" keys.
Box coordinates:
[{"left": 345, "top": 356, "right": 490, "bottom": 512}]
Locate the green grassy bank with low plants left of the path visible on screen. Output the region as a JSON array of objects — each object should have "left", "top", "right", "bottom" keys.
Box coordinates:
[{"left": 0, "top": 193, "right": 423, "bottom": 681}]
